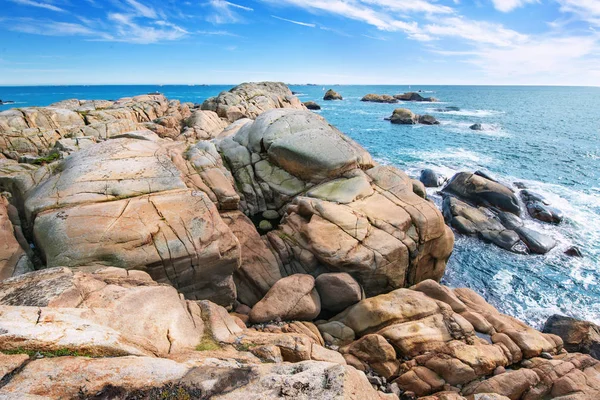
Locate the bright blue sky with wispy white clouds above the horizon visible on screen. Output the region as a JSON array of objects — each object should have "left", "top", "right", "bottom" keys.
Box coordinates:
[{"left": 0, "top": 0, "right": 600, "bottom": 86}]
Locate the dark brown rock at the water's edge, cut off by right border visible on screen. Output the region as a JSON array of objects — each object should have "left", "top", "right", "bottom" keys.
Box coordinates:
[{"left": 543, "top": 315, "right": 600, "bottom": 360}]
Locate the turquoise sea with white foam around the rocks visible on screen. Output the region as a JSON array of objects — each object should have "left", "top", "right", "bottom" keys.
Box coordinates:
[{"left": 0, "top": 86, "right": 600, "bottom": 327}]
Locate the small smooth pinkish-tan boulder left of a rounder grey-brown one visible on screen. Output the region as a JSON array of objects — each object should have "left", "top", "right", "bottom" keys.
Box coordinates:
[{"left": 250, "top": 274, "right": 321, "bottom": 323}]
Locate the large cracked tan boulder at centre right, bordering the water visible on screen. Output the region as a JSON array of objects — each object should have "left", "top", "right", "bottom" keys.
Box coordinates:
[{"left": 268, "top": 163, "right": 454, "bottom": 296}]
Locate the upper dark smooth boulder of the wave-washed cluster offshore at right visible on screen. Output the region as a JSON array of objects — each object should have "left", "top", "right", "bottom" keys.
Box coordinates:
[{"left": 442, "top": 172, "right": 521, "bottom": 215}]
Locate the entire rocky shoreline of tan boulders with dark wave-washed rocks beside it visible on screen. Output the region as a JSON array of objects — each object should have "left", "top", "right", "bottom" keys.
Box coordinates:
[{"left": 0, "top": 82, "right": 600, "bottom": 400}]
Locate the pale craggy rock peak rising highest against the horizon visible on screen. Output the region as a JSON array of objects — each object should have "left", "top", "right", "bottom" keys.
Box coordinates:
[{"left": 202, "top": 82, "right": 305, "bottom": 122}]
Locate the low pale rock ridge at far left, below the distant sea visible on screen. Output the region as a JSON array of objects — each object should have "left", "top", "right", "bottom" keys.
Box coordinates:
[{"left": 0, "top": 95, "right": 195, "bottom": 159}]
